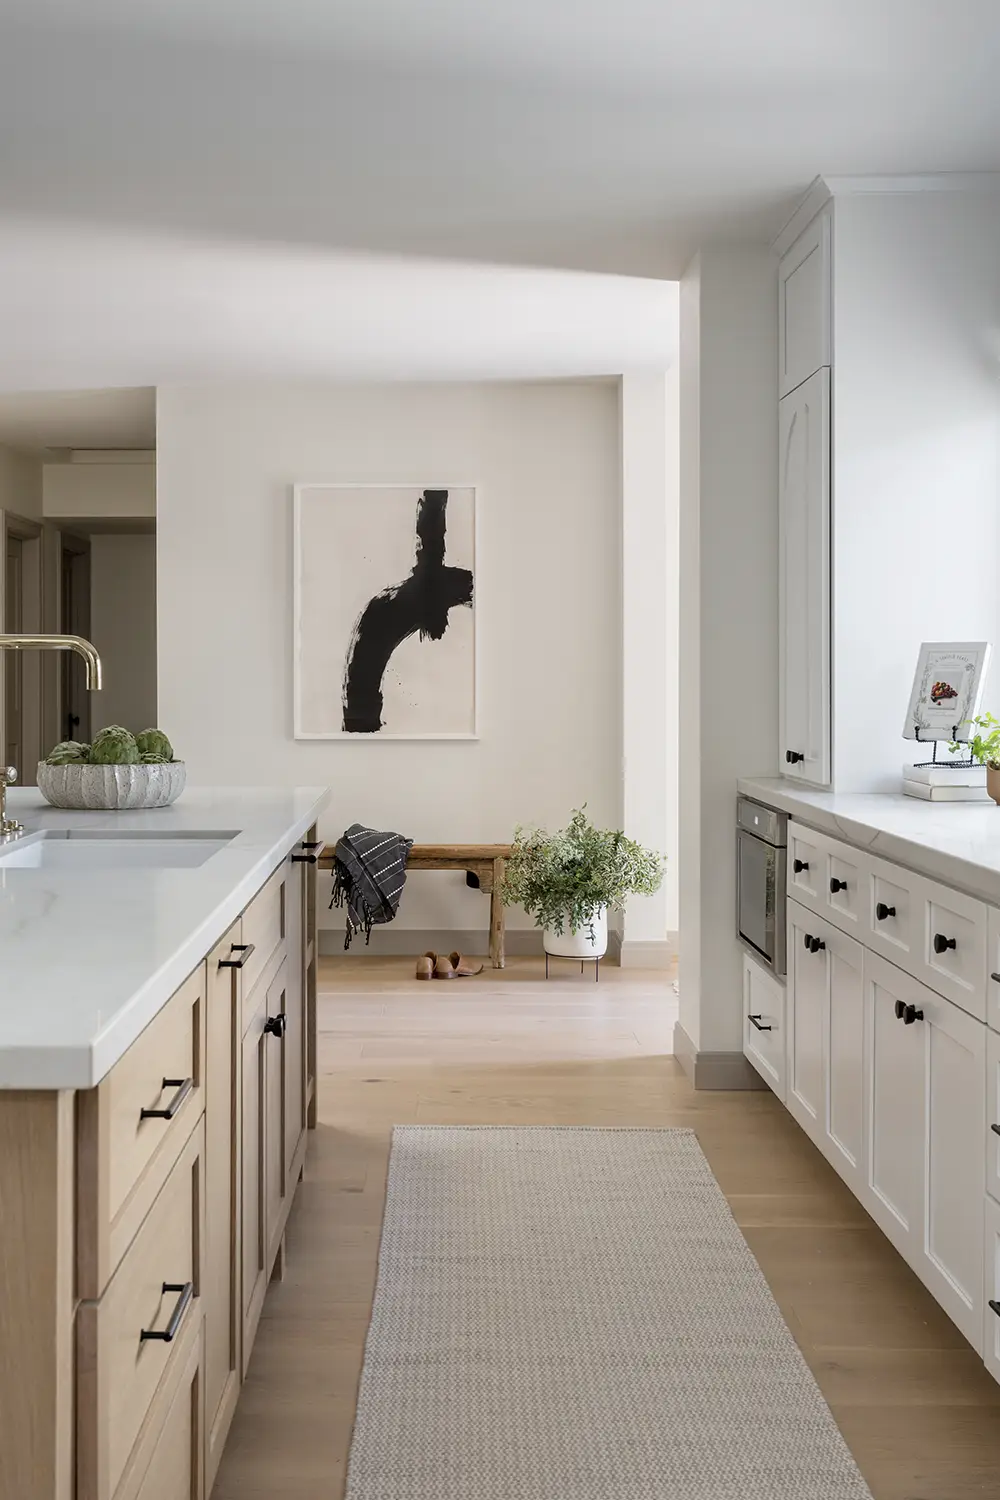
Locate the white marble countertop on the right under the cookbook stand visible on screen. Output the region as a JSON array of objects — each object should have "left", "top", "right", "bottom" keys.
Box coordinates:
[{"left": 736, "top": 777, "right": 1000, "bottom": 906}]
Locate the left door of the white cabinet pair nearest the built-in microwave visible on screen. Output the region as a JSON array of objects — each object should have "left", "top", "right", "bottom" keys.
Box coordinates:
[{"left": 787, "top": 902, "right": 828, "bottom": 1145}]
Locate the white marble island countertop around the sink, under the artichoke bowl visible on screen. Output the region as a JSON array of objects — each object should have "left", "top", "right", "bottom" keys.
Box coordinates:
[{"left": 0, "top": 786, "right": 328, "bottom": 1089}]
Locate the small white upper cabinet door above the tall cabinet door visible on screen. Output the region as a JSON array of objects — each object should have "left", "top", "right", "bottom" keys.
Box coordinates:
[{"left": 778, "top": 213, "right": 831, "bottom": 396}]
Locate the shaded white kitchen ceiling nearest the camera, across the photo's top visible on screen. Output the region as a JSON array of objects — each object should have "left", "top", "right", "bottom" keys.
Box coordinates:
[{"left": 0, "top": 0, "right": 1000, "bottom": 276}]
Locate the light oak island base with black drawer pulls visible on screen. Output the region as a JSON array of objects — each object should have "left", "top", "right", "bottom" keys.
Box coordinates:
[{"left": 0, "top": 831, "right": 316, "bottom": 1500}]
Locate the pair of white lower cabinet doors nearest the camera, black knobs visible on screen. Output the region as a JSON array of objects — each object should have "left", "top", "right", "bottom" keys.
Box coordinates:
[{"left": 862, "top": 953, "right": 987, "bottom": 1349}]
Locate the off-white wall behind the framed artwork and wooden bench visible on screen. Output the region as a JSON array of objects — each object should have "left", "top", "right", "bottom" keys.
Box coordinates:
[{"left": 157, "top": 381, "right": 622, "bottom": 930}]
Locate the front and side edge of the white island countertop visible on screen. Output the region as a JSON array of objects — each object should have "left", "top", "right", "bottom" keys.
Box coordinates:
[{"left": 0, "top": 788, "right": 330, "bottom": 1094}]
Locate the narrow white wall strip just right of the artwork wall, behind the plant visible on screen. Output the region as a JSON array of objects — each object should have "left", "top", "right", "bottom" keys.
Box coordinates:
[{"left": 621, "top": 371, "right": 678, "bottom": 963}]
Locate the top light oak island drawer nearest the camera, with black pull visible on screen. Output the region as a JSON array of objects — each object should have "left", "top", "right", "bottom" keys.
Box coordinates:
[{"left": 76, "top": 963, "right": 205, "bottom": 1299}]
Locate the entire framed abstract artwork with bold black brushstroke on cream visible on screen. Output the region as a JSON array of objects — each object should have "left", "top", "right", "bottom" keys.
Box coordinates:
[{"left": 294, "top": 485, "right": 478, "bottom": 741}]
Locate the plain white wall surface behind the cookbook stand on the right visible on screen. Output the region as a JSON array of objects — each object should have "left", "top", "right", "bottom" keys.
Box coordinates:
[{"left": 834, "top": 192, "right": 1000, "bottom": 792}]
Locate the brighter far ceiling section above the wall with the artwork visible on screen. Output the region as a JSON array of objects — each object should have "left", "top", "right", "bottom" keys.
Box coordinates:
[{"left": 0, "top": 219, "right": 678, "bottom": 396}]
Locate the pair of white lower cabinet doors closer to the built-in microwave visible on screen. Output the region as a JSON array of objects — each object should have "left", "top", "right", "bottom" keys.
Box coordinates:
[{"left": 786, "top": 902, "right": 865, "bottom": 1187}]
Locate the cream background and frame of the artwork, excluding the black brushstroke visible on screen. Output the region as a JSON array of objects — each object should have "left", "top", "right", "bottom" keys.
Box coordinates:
[{"left": 292, "top": 480, "right": 480, "bottom": 744}]
